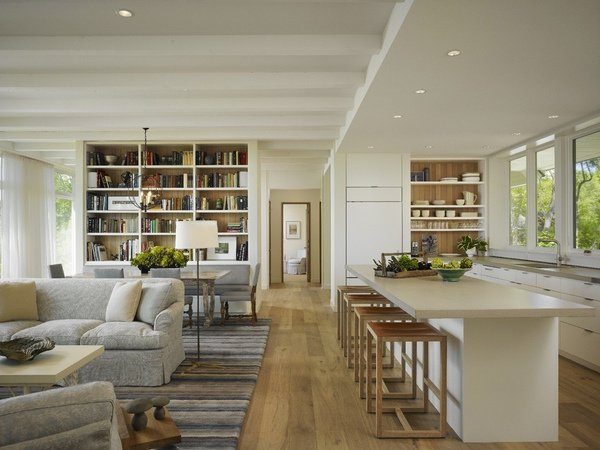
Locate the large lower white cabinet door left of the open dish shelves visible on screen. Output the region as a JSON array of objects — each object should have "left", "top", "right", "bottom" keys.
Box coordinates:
[{"left": 346, "top": 203, "right": 402, "bottom": 264}]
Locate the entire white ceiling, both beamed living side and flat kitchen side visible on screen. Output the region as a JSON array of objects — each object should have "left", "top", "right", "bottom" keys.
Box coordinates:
[{"left": 0, "top": 0, "right": 600, "bottom": 167}]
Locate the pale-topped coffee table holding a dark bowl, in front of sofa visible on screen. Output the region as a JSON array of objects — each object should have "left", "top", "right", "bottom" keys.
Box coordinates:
[{"left": 0, "top": 345, "right": 104, "bottom": 394}]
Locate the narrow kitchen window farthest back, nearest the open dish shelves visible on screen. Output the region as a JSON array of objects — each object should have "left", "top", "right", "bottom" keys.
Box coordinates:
[{"left": 510, "top": 156, "right": 527, "bottom": 246}]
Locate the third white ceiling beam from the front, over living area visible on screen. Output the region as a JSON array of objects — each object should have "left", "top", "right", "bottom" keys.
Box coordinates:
[{"left": 0, "top": 97, "right": 352, "bottom": 115}]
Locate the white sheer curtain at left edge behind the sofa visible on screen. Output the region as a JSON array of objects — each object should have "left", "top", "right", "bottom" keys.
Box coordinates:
[{"left": 0, "top": 153, "right": 56, "bottom": 278}]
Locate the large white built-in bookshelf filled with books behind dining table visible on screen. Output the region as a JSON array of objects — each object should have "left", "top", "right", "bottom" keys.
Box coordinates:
[{"left": 82, "top": 141, "right": 251, "bottom": 266}]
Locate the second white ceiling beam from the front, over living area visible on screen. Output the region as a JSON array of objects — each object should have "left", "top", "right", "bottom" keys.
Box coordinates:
[{"left": 0, "top": 72, "right": 364, "bottom": 90}]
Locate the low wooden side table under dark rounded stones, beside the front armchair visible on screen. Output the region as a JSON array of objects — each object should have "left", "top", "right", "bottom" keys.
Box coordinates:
[{"left": 118, "top": 404, "right": 181, "bottom": 450}]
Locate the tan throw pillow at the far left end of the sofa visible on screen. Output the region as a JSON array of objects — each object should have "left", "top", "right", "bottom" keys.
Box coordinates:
[{"left": 0, "top": 281, "right": 38, "bottom": 322}]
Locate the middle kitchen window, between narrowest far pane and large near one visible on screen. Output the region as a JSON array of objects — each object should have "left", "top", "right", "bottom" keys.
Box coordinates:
[{"left": 535, "top": 147, "right": 556, "bottom": 247}]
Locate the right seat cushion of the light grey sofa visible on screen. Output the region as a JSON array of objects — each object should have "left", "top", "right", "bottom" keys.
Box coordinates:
[{"left": 80, "top": 322, "right": 168, "bottom": 350}]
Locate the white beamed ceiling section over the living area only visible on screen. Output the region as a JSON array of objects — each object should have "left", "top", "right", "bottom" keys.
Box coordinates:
[{"left": 0, "top": 0, "right": 395, "bottom": 163}]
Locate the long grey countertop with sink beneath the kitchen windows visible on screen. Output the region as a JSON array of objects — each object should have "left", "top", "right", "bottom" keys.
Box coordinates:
[{"left": 472, "top": 256, "right": 600, "bottom": 282}]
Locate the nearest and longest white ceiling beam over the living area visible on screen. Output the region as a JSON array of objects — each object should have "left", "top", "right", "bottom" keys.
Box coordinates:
[{"left": 0, "top": 34, "right": 381, "bottom": 58}]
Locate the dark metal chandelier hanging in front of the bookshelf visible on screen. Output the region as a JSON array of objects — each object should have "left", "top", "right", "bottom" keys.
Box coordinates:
[{"left": 121, "top": 127, "right": 161, "bottom": 212}]
